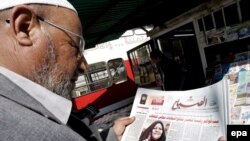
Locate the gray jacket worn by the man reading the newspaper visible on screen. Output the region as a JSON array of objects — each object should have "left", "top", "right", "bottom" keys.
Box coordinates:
[{"left": 0, "top": 74, "right": 117, "bottom": 141}]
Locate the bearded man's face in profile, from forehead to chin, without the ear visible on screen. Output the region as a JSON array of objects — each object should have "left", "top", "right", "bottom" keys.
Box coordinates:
[{"left": 32, "top": 9, "right": 83, "bottom": 98}]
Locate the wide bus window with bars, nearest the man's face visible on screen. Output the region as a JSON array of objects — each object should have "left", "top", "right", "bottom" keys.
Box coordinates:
[{"left": 72, "top": 61, "right": 112, "bottom": 98}]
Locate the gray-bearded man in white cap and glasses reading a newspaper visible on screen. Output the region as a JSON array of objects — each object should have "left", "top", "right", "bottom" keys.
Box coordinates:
[{"left": 0, "top": 0, "right": 134, "bottom": 141}]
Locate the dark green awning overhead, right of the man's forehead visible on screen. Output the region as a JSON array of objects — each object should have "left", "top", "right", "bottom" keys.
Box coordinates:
[{"left": 69, "top": 0, "right": 209, "bottom": 49}]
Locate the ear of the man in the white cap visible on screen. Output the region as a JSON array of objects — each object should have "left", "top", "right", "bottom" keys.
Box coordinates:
[{"left": 10, "top": 5, "right": 38, "bottom": 46}]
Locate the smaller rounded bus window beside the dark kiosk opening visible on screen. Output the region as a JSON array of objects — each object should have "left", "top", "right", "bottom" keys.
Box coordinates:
[{"left": 108, "top": 58, "right": 127, "bottom": 84}]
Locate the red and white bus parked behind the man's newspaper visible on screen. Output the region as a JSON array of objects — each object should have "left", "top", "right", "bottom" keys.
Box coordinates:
[{"left": 72, "top": 29, "right": 149, "bottom": 116}]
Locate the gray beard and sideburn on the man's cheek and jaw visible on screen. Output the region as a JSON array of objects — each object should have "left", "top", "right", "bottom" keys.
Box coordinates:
[{"left": 32, "top": 31, "right": 74, "bottom": 99}]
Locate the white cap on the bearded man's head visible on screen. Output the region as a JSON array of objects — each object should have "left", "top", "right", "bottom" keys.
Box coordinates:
[{"left": 0, "top": 0, "right": 77, "bottom": 12}]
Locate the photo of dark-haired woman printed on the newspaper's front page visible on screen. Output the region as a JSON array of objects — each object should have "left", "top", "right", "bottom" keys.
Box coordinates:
[{"left": 139, "top": 121, "right": 166, "bottom": 141}]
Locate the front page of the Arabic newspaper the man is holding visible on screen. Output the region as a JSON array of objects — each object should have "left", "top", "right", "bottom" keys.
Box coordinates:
[{"left": 122, "top": 79, "right": 226, "bottom": 141}]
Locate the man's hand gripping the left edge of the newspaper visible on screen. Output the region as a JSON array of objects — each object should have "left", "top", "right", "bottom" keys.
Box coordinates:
[{"left": 113, "top": 117, "right": 135, "bottom": 141}]
